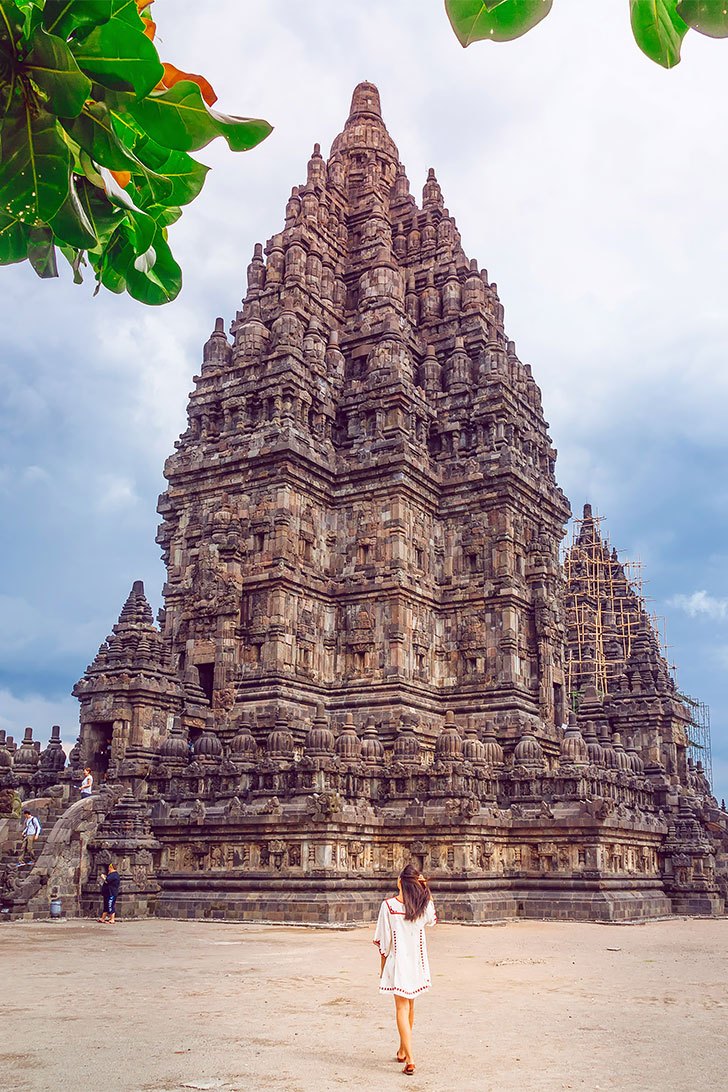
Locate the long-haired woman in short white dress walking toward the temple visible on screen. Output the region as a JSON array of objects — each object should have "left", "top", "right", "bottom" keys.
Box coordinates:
[{"left": 374, "top": 865, "right": 438, "bottom": 1077}]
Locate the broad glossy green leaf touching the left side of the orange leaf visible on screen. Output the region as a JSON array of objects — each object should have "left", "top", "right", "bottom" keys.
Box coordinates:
[{"left": 71, "top": 17, "right": 164, "bottom": 98}]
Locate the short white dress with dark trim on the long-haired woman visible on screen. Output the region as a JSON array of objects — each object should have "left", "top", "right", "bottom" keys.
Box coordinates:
[{"left": 374, "top": 898, "right": 438, "bottom": 999}]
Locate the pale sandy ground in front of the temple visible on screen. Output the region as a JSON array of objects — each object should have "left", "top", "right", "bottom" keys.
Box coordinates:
[{"left": 0, "top": 919, "right": 728, "bottom": 1092}]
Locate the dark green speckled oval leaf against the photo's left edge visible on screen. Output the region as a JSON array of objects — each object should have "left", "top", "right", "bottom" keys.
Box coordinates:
[{"left": 0, "top": 99, "right": 70, "bottom": 224}]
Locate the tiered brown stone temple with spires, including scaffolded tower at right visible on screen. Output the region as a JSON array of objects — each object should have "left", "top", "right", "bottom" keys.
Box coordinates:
[{"left": 0, "top": 83, "right": 727, "bottom": 923}]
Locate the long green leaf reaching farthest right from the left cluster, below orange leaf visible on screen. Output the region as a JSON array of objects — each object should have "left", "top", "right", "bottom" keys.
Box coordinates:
[{"left": 129, "top": 80, "right": 273, "bottom": 152}]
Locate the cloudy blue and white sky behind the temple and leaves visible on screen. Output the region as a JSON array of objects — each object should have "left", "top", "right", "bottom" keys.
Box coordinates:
[{"left": 0, "top": 0, "right": 728, "bottom": 796}]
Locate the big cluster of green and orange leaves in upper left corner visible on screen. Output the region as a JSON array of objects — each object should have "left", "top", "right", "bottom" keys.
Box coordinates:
[{"left": 0, "top": 0, "right": 271, "bottom": 304}]
